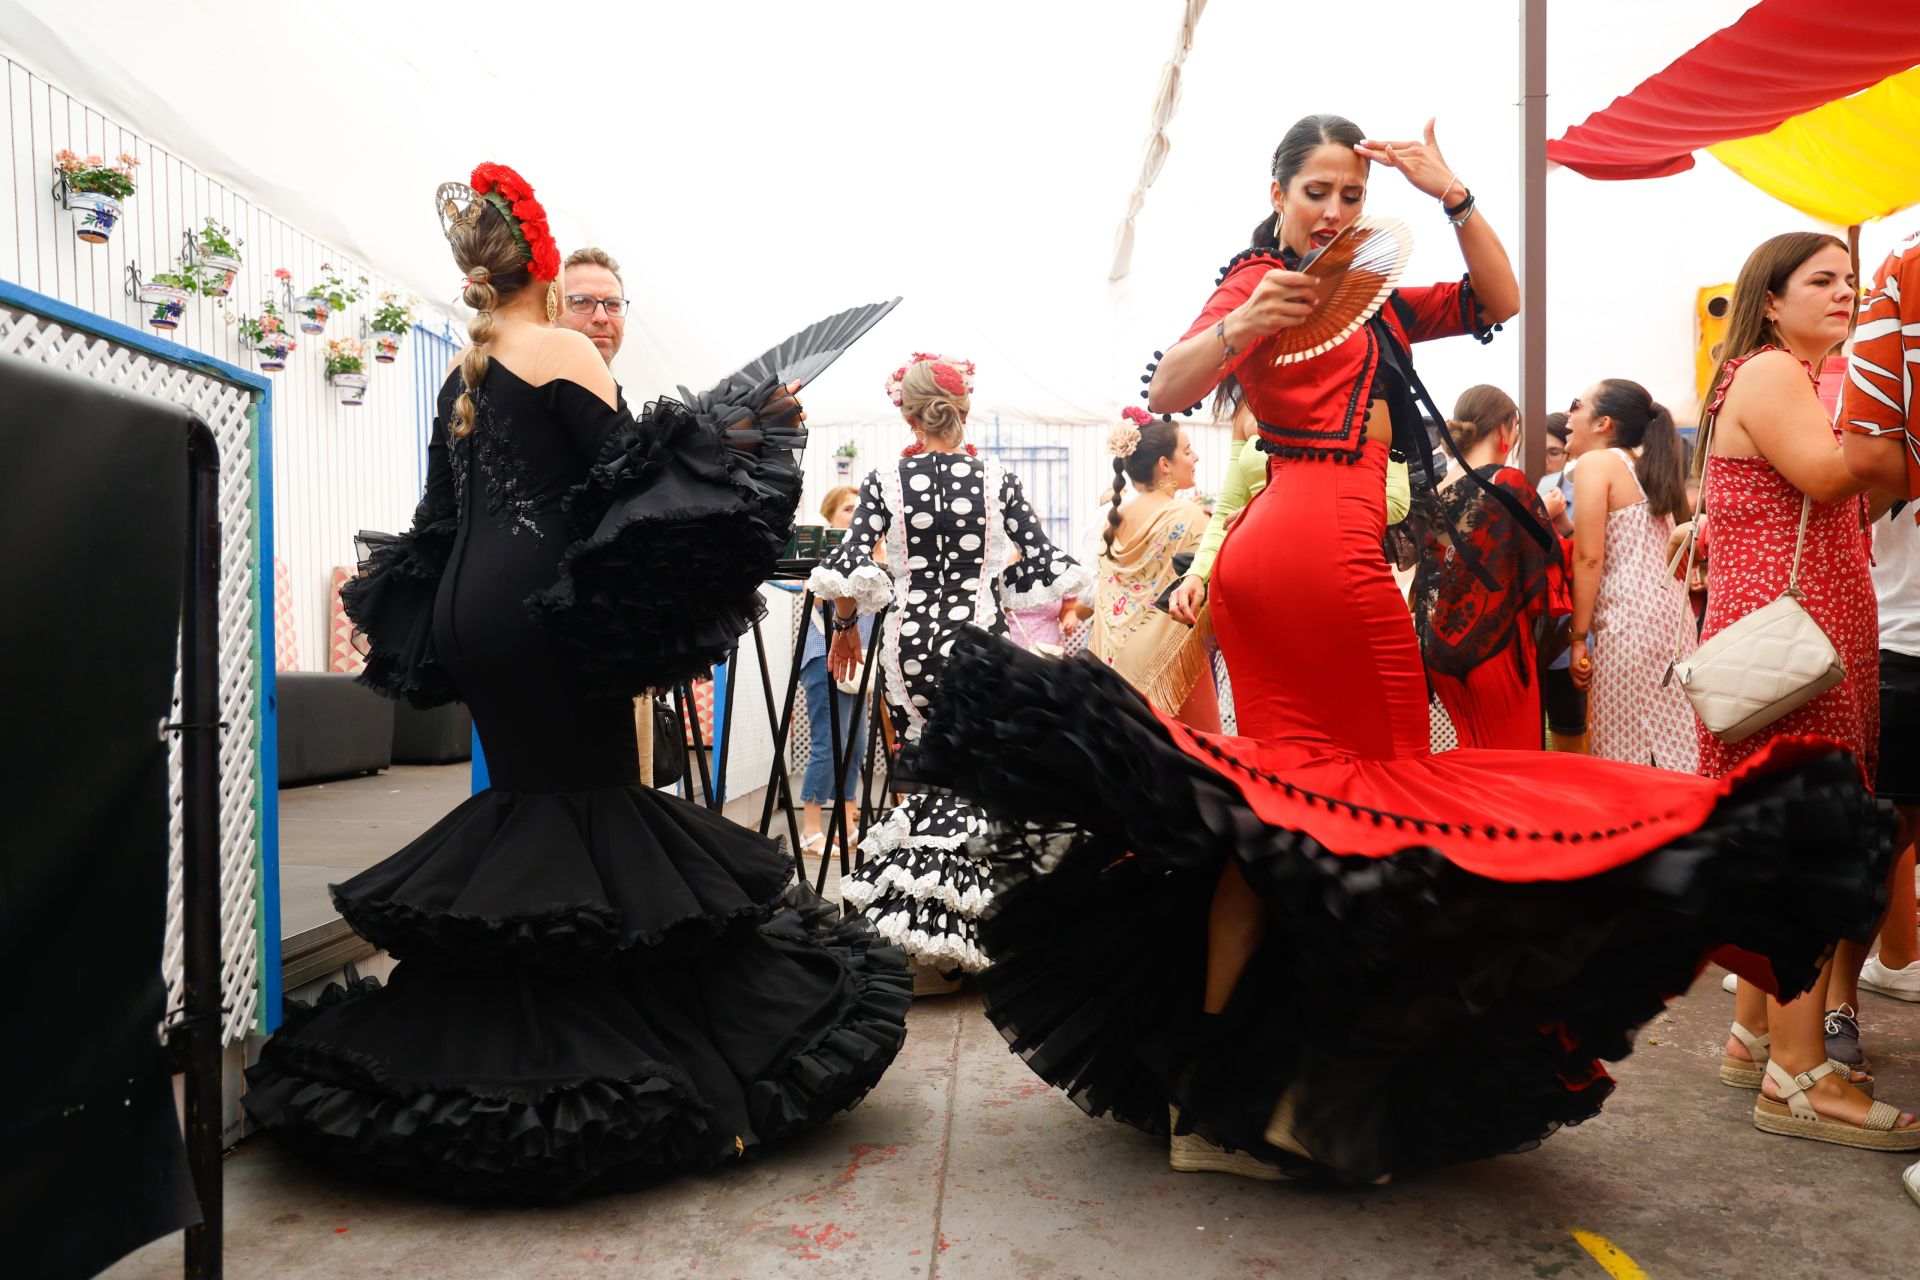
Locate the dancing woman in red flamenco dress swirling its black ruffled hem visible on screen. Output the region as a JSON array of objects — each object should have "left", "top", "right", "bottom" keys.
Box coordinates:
[{"left": 912, "top": 117, "right": 1893, "bottom": 1182}]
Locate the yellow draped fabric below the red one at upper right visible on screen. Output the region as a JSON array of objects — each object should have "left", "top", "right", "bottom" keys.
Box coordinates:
[{"left": 1707, "top": 67, "right": 1920, "bottom": 226}]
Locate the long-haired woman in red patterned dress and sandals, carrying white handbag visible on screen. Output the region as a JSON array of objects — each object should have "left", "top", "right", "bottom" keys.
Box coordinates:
[{"left": 1699, "top": 232, "right": 1920, "bottom": 1151}]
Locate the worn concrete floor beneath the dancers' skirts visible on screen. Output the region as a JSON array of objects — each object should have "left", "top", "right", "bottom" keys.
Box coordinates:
[{"left": 106, "top": 971, "right": 1920, "bottom": 1280}]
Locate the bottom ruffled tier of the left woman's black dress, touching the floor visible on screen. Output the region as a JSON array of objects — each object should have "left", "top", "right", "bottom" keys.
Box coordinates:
[{"left": 242, "top": 902, "right": 912, "bottom": 1201}]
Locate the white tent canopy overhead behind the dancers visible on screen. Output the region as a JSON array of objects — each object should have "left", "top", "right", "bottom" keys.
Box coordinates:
[{"left": 0, "top": 0, "right": 1901, "bottom": 424}]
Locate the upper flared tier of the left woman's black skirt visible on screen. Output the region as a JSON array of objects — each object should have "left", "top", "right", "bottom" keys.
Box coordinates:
[{"left": 332, "top": 787, "right": 793, "bottom": 973}]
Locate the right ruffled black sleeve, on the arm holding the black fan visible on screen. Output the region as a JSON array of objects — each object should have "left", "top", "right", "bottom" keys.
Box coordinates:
[{"left": 528, "top": 399, "right": 804, "bottom": 695}]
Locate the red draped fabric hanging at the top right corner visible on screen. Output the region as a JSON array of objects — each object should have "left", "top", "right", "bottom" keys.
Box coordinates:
[{"left": 1548, "top": 0, "right": 1920, "bottom": 180}]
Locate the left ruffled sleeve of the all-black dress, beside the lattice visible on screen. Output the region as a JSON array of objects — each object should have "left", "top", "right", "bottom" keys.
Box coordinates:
[{"left": 340, "top": 416, "right": 461, "bottom": 706}]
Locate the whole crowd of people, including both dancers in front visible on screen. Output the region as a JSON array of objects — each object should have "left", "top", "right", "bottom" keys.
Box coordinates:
[{"left": 246, "top": 115, "right": 1920, "bottom": 1220}]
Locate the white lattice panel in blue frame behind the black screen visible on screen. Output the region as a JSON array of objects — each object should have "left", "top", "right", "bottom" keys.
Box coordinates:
[{"left": 0, "top": 299, "right": 261, "bottom": 1042}]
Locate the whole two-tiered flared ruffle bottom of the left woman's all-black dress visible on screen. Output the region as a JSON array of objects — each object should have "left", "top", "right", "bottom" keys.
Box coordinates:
[{"left": 244, "top": 787, "right": 912, "bottom": 1199}]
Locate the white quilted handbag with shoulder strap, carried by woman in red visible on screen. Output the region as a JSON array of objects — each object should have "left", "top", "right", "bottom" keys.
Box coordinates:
[{"left": 1663, "top": 404, "right": 1847, "bottom": 743}]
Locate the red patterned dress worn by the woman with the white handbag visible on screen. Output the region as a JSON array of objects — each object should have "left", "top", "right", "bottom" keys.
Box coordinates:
[{"left": 1697, "top": 347, "right": 1880, "bottom": 787}]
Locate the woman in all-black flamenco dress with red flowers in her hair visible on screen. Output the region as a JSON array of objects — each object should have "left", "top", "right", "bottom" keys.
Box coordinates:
[{"left": 244, "top": 167, "right": 912, "bottom": 1199}]
